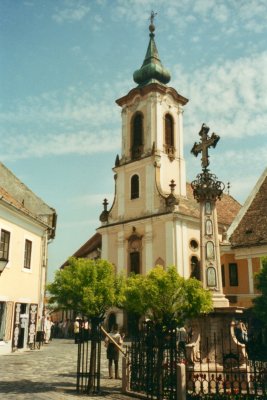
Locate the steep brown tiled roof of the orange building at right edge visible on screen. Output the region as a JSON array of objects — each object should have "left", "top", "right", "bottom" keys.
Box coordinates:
[{"left": 228, "top": 168, "right": 267, "bottom": 248}]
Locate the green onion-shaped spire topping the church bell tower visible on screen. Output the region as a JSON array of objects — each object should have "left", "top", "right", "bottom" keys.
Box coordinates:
[{"left": 133, "top": 22, "right": 171, "bottom": 87}]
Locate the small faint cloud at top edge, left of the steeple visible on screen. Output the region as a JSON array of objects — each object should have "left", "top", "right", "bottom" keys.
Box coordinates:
[{"left": 52, "top": 0, "right": 90, "bottom": 23}]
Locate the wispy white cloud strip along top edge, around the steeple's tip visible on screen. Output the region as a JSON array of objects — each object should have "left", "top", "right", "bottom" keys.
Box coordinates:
[{"left": 113, "top": 0, "right": 267, "bottom": 33}]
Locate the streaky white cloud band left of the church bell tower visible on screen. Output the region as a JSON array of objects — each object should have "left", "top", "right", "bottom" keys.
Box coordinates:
[{"left": 0, "top": 75, "right": 132, "bottom": 161}]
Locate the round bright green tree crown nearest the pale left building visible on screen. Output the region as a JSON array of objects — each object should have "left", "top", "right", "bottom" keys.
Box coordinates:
[{"left": 47, "top": 257, "right": 120, "bottom": 318}]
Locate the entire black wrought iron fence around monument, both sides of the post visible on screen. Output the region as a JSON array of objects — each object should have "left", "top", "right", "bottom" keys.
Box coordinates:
[{"left": 129, "top": 323, "right": 267, "bottom": 400}]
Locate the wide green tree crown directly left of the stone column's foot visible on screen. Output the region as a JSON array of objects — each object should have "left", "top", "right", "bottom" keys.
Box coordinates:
[{"left": 123, "top": 266, "right": 212, "bottom": 326}]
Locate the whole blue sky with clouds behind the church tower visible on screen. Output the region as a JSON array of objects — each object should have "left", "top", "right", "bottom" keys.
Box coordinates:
[{"left": 0, "top": 0, "right": 267, "bottom": 280}]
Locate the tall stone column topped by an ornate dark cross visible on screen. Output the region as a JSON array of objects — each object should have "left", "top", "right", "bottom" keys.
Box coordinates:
[{"left": 191, "top": 124, "right": 229, "bottom": 308}]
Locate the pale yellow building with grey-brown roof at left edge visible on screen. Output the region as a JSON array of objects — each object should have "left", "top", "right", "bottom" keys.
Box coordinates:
[{"left": 0, "top": 163, "right": 56, "bottom": 354}]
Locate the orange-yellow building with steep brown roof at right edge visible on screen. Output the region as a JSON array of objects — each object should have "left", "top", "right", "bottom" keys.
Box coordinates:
[{"left": 221, "top": 168, "right": 267, "bottom": 307}]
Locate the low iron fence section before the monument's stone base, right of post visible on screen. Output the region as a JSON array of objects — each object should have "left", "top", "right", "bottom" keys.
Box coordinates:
[{"left": 186, "top": 332, "right": 267, "bottom": 400}]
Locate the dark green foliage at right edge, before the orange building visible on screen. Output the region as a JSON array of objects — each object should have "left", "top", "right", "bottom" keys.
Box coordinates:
[{"left": 253, "top": 257, "right": 267, "bottom": 327}]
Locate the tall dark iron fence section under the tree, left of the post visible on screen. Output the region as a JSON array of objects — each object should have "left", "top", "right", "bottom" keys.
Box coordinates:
[{"left": 129, "top": 323, "right": 185, "bottom": 400}]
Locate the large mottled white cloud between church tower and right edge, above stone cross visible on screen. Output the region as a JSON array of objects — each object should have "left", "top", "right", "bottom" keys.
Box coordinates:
[{"left": 172, "top": 52, "right": 267, "bottom": 143}]
